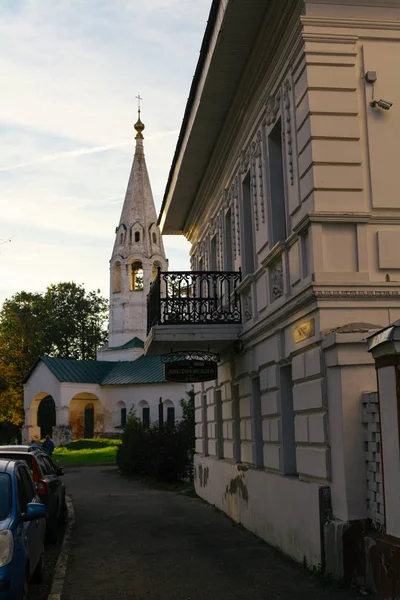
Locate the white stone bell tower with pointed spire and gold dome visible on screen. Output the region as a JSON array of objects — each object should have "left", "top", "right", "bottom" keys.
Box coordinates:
[{"left": 108, "top": 106, "right": 168, "bottom": 350}]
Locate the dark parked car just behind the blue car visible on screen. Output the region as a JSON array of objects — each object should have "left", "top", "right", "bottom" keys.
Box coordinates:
[{"left": 0, "top": 446, "right": 67, "bottom": 540}]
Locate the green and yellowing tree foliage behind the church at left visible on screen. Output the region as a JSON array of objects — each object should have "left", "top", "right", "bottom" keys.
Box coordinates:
[{"left": 0, "top": 282, "right": 107, "bottom": 426}]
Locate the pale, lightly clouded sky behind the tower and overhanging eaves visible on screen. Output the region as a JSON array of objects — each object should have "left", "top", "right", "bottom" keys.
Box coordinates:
[{"left": 0, "top": 0, "right": 211, "bottom": 304}]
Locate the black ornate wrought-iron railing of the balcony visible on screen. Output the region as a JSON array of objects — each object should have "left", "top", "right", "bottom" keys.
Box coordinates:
[{"left": 147, "top": 270, "right": 242, "bottom": 333}]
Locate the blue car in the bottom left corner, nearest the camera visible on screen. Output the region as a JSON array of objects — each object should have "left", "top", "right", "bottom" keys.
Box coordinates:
[{"left": 0, "top": 459, "right": 46, "bottom": 600}]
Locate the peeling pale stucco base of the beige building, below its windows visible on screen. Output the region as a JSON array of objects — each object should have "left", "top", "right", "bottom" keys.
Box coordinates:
[{"left": 195, "top": 455, "right": 321, "bottom": 565}]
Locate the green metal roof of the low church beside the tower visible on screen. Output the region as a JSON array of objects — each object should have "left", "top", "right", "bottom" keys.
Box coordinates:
[{"left": 35, "top": 356, "right": 165, "bottom": 385}]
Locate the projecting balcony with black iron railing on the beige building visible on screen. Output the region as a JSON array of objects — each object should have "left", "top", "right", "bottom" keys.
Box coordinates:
[{"left": 145, "top": 271, "right": 242, "bottom": 355}]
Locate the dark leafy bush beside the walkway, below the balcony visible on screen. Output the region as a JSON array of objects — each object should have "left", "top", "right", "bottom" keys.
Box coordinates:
[{"left": 117, "top": 394, "right": 194, "bottom": 482}]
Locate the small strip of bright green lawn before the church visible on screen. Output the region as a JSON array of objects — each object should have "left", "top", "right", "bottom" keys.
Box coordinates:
[{"left": 52, "top": 439, "right": 121, "bottom": 467}]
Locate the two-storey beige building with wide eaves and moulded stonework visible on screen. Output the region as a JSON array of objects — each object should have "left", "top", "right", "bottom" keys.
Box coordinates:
[{"left": 145, "top": 0, "right": 400, "bottom": 575}]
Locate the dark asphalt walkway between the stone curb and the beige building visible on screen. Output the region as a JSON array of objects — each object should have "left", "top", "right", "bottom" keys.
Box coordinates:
[{"left": 62, "top": 467, "right": 368, "bottom": 600}]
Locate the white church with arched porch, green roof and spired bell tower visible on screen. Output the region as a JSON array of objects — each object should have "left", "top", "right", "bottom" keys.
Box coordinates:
[{"left": 23, "top": 109, "right": 186, "bottom": 444}]
